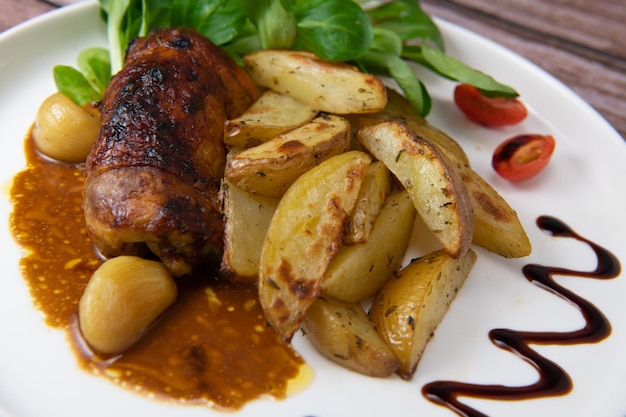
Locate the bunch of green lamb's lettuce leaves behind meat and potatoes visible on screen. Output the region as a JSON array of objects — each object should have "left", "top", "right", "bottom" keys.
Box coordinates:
[{"left": 54, "top": 0, "right": 518, "bottom": 116}]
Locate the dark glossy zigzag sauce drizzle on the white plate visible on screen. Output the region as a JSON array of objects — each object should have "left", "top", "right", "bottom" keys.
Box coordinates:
[{"left": 422, "top": 216, "right": 621, "bottom": 417}]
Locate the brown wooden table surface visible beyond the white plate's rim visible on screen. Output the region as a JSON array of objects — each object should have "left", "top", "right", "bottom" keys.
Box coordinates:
[{"left": 0, "top": 0, "right": 626, "bottom": 139}]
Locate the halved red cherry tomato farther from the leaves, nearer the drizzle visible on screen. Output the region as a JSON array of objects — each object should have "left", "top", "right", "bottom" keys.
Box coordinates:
[{"left": 491, "top": 134, "right": 556, "bottom": 181}]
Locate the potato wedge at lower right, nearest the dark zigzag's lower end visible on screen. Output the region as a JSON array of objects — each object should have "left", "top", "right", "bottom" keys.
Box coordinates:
[{"left": 369, "top": 249, "right": 476, "bottom": 379}]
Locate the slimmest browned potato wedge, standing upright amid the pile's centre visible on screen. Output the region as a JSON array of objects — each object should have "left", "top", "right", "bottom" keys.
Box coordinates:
[{"left": 343, "top": 161, "right": 391, "bottom": 245}]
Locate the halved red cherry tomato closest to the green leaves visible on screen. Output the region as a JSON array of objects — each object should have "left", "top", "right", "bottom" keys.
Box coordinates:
[{"left": 454, "top": 84, "right": 528, "bottom": 127}]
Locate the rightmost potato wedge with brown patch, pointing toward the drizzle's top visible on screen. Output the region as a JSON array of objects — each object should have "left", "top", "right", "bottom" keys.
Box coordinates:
[{"left": 461, "top": 168, "right": 532, "bottom": 258}]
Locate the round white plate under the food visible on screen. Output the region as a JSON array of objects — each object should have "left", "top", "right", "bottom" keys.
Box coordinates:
[{"left": 0, "top": 2, "right": 626, "bottom": 417}]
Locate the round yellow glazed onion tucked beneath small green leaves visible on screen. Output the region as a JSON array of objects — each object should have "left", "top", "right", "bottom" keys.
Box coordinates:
[{"left": 33, "top": 93, "right": 100, "bottom": 162}]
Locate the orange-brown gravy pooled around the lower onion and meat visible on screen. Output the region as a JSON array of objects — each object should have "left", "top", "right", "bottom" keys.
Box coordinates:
[{"left": 10, "top": 135, "right": 306, "bottom": 411}]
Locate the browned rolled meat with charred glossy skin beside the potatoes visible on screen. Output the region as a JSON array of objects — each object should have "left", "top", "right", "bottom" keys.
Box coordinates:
[{"left": 84, "top": 28, "right": 258, "bottom": 276}]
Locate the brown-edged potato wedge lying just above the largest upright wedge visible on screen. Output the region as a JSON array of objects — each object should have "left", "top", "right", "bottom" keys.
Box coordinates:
[{"left": 224, "top": 115, "right": 350, "bottom": 198}]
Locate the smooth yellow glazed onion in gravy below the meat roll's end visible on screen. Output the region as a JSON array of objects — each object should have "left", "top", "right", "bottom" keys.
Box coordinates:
[{"left": 78, "top": 256, "right": 177, "bottom": 355}]
